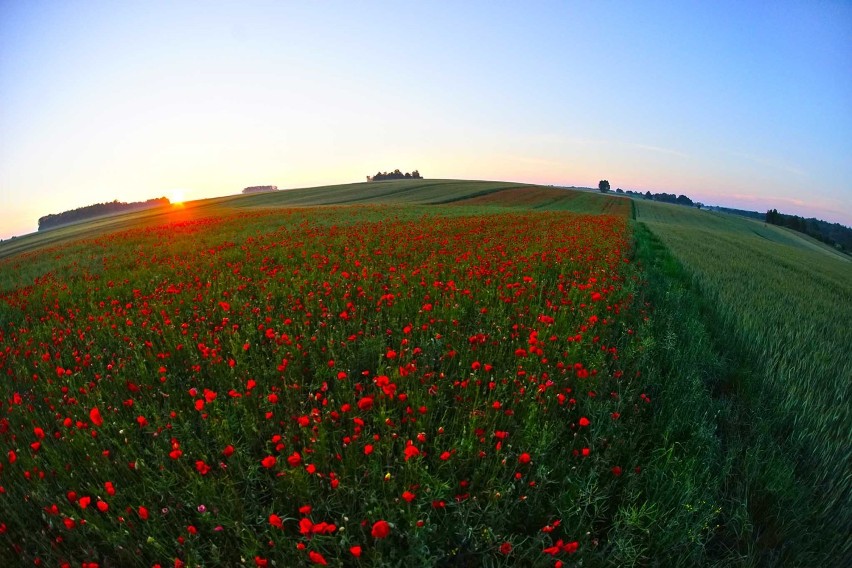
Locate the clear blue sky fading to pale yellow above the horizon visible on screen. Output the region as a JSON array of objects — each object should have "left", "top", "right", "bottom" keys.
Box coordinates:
[{"left": 0, "top": 0, "right": 852, "bottom": 238}]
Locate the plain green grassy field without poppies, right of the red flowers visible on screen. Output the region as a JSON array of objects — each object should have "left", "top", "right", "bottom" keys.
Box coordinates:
[{"left": 636, "top": 201, "right": 852, "bottom": 565}]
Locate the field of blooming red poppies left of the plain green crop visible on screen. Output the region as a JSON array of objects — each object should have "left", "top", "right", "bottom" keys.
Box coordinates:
[{"left": 0, "top": 201, "right": 656, "bottom": 567}]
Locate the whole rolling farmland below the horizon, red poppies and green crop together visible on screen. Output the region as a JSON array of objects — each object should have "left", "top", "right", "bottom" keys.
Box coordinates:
[{"left": 0, "top": 180, "right": 852, "bottom": 567}]
